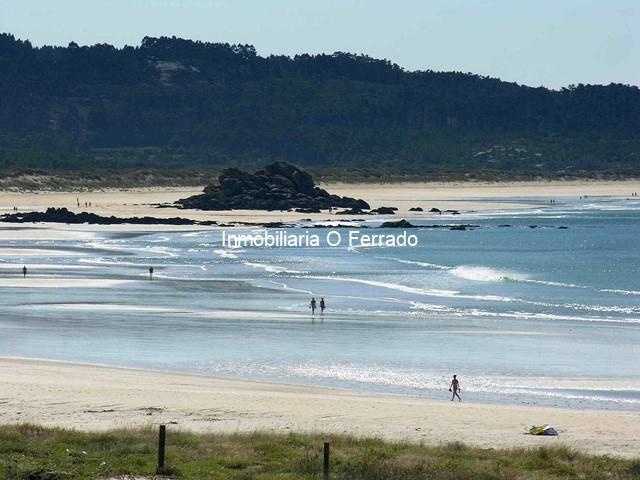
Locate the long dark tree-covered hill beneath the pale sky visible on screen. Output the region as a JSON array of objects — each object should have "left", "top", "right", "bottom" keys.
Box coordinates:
[{"left": 0, "top": 34, "right": 640, "bottom": 174}]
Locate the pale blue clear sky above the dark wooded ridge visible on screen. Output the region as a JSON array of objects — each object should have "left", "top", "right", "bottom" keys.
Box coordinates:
[{"left": 0, "top": 0, "right": 640, "bottom": 88}]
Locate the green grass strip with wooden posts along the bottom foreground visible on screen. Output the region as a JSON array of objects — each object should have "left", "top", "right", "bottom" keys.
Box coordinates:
[{"left": 0, "top": 425, "right": 640, "bottom": 480}]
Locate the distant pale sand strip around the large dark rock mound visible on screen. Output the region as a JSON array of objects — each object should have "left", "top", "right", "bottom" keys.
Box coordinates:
[{"left": 0, "top": 180, "right": 640, "bottom": 223}]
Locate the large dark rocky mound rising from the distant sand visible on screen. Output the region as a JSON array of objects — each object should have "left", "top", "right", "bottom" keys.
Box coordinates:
[{"left": 176, "top": 162, "right": 369, "bottom": 211}]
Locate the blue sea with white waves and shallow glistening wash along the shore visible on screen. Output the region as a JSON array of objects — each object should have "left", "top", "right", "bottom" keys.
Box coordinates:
[{"left": 0, "top": 197, "right": 640, "bottom": 409}]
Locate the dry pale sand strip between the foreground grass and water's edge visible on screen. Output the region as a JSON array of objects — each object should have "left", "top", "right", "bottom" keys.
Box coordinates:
[{"left": 0, "top": 359, "right": 640, "bottom": 457}]
